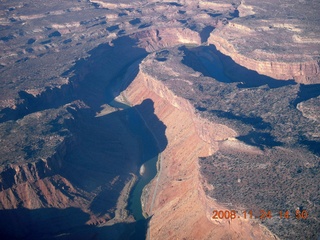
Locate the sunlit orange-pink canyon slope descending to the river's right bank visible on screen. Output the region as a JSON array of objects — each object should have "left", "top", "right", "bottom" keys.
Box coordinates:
[{"left": 125, "top": 63, "right": 275, "bottom": 239}]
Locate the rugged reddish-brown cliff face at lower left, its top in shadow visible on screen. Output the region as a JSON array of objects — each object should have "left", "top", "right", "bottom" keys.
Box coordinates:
[{"left": 0, "top": 140, "right": 67, "bottom": 209}]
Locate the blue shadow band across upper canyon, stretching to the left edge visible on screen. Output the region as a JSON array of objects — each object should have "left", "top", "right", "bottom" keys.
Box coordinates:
[{"left": 0, "top": 36, "right": 147, "bottom": 123}]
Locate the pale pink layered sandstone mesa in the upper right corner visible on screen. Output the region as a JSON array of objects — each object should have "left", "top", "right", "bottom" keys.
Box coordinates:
[{"left": 208, "top": 0, "right": 320, "bottom": 84}]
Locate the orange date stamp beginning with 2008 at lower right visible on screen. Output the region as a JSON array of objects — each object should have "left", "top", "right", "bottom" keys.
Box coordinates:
[{"left": 212, "top": 209, "right": 308, "bottom": 220}]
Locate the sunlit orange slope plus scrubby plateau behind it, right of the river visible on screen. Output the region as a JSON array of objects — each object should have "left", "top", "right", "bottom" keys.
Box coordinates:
[{"left": 127, "top": 48, "right": 319, "bottom": 239}]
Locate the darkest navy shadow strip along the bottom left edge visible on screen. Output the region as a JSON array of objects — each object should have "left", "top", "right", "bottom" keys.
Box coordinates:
[{"left": 0, "top": 208, "right": 149, "bottom": 240}]
